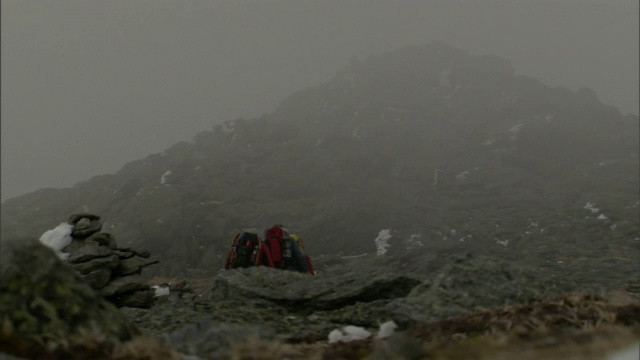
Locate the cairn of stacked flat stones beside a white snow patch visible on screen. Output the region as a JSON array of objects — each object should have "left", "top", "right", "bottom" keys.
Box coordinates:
[{"left": 62, "top": 213, "right": 158, "bottom": 309}]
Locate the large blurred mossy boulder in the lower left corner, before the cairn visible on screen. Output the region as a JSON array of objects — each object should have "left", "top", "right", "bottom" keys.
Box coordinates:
[{"left": 0, "top": 239, "right": 140, "bottom": 358}]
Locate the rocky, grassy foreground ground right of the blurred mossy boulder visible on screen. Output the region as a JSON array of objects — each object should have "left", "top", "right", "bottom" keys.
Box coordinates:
[{"left": 121, "top": 250, "right": 640, "bottom": 359}]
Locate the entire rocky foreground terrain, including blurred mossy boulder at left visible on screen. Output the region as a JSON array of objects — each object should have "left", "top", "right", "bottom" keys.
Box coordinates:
[{"left": 0, "top": 236, "right": 640, "bottom": 359}]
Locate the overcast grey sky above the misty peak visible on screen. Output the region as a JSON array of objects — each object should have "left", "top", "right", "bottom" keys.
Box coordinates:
[{"left": 1, "top": 0, "right": 639, "bottom": 200}]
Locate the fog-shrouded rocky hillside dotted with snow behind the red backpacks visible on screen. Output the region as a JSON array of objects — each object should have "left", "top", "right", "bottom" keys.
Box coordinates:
[{"left": 1, "top": 43, "right": 640, "bottom": 281}]
